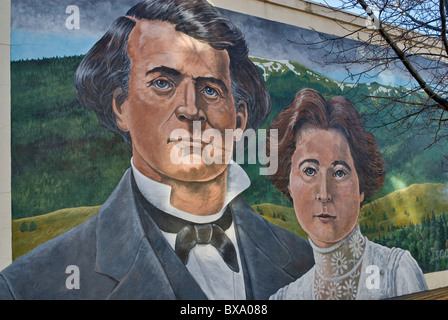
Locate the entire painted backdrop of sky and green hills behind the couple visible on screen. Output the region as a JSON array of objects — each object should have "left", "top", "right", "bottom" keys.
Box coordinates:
[{"left": 11, "top": 0, "right": 448, "bottom": 273}]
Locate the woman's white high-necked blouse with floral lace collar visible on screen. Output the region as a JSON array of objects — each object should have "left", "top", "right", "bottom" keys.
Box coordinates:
[{"left": 270, "top": 226, "right": 428, "bottom": 300}]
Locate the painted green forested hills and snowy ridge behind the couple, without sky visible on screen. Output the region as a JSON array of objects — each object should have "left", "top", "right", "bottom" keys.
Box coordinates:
[{"left": 11, "top": 56, "right": 448, "bottom": 272}]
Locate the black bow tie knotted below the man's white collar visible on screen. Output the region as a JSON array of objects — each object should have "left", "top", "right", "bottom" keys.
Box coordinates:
[{"left": 132, "top": 172, "right": 239, "bottom": 272}]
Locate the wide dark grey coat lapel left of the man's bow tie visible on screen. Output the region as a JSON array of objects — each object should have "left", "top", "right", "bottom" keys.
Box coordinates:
[{"left": 95, "top": 170, "right": 206, "bottom": 299}]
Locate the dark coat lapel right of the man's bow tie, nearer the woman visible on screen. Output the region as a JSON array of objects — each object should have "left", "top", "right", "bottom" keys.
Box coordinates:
[{"left": 232, "top": 197, "right": 295, "bottom": 300}]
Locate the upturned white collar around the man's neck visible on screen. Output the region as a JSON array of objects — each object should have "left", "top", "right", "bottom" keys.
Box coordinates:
[{"left": 131, "top": 158, "right": 250, "bottom": 223}]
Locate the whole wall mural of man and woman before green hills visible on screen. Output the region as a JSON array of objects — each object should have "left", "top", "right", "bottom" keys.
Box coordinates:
[{"left": 0, "top": 0, "right": 448, "bottom": 300}]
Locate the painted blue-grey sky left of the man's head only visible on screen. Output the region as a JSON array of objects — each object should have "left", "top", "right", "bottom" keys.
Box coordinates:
[{"left": 11, "top": 0, "right": 364, "bottom": 61}]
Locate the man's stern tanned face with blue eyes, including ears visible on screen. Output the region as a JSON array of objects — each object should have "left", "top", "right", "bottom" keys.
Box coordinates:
[{"left": 114, "top": 20, "right": 246, "bottom": 181}]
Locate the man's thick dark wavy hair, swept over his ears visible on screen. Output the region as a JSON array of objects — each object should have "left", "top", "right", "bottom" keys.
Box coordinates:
[{"left": 74, "top": 0, "right": 271, "bottom": 145}]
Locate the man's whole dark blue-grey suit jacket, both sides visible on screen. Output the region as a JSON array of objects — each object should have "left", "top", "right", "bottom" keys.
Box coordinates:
[{"left": 0, "top": 170, "right": 314, "bottom": 300}]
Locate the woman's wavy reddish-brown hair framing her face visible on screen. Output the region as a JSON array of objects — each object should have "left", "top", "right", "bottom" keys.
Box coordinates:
[{"left": 266, "top": 89, "right": 386, "bottom": 201}]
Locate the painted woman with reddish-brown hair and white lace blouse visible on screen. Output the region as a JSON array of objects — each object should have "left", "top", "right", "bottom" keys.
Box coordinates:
[{"left": 267, "top": 89, "right": 427, "bottom": 300}]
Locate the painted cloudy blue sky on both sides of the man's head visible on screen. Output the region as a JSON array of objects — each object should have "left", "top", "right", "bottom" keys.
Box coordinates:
[{"left": 7, "top": 0, "right": 407, "bottom": 84}]
